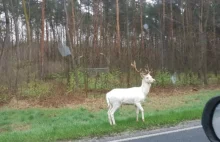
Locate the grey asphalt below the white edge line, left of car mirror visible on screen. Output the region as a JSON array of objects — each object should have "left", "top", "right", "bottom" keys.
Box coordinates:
[{"left": 115, "top": 128, "right": 209, "bottom": 142}]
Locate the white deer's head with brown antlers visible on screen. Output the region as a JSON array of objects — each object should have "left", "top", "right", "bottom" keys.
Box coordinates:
[{"left": 131, "top": 61, "right": 155, "bottom": 84}]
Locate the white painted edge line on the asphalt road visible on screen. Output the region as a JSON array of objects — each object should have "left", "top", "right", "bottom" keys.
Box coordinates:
[{"left": 111, "top": 125, "right": 202, "bottom": 142}]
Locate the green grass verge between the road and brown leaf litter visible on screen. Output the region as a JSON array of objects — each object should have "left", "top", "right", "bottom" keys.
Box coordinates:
[{"left": 0, "top": 90, "right": 220, "bottom": 142}]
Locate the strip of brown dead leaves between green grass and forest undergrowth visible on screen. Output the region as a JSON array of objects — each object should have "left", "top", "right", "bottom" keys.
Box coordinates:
[{"left": 3, "top": 85, "right": 220, "bottom": 111}]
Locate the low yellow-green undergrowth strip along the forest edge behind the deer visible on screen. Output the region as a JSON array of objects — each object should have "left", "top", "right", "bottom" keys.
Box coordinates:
[{"left": 0, "top": 70, "right": 220, "bottom": 103}]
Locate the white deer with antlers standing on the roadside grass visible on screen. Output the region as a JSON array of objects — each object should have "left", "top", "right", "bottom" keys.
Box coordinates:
[{"left": 106, "top": 61, "right": 155, "bottom": 125}]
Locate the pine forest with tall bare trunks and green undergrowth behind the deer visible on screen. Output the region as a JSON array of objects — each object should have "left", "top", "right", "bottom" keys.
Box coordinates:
[{"left": 0, "top": 0, "right": 220, "bottom": 103}]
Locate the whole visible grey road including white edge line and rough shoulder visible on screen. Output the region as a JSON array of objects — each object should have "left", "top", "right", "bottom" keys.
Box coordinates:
[{"left": 79, "top": 120, "right": 209, "bottom": 142}]
